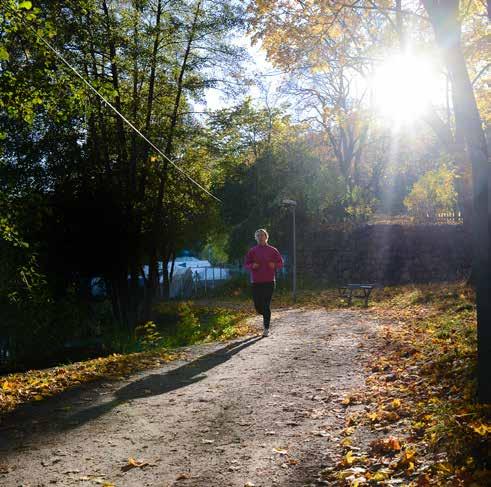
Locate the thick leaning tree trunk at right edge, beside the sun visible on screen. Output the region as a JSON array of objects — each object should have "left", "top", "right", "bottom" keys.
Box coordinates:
[{"left": 423, "top": 0, "right": 491, "bottom": 403}]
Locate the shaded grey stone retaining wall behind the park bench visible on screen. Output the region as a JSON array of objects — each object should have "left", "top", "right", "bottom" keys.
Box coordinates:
[{"left": 297, "top": 224, "right": 472, "bottom": 285}]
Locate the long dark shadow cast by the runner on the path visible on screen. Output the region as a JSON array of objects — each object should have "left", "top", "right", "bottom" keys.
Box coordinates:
[{"left": 62, "top": 337, "right": 260, "bottom": 429}]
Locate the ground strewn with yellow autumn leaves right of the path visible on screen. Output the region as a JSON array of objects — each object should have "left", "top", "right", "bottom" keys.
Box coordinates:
[{"left": 320, "top": 285, "right": 491, "bottom": 487}]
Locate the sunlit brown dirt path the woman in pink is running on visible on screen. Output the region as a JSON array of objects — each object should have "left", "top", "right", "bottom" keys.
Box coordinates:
[{"left": 0, "top": 309, "right": 377, "bottom": 487}]
